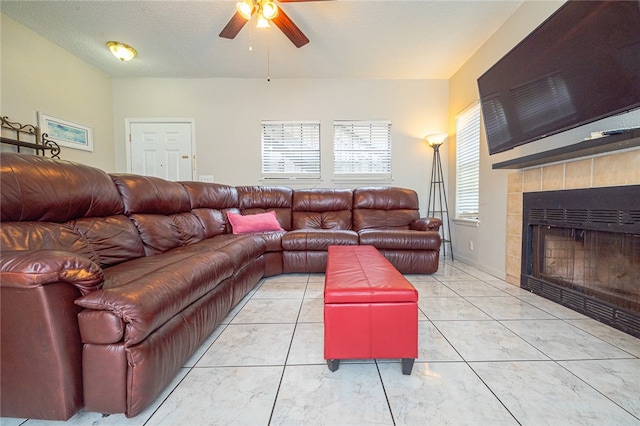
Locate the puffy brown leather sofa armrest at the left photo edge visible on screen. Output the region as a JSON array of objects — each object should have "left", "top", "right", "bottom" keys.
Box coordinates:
[{"left": 0, "top": 250, "right": 104, "bottom": 295}]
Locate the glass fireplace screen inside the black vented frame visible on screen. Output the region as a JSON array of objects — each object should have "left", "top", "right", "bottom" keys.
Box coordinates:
[{"left": 532, "top": 225, "right": 640, "bottom": 313}]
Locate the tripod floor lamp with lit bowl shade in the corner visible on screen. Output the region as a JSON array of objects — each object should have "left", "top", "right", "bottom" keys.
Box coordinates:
[{"left": 424, "top": 133, "right": 453, "bottom": 261}]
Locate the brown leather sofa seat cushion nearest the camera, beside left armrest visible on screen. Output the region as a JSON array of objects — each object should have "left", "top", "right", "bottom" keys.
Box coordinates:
[{"left": 75, "top": 250, "right": 234, "bottom": 346}]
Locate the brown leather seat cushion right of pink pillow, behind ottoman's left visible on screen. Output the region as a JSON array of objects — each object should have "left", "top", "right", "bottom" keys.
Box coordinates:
[{"left": 282, "top": 229, "right": 358, "bottom": 251}]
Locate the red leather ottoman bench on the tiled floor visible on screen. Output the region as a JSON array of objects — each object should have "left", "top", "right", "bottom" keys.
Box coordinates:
[{"left": 324, "top": 245, "right": 418, "bottom": 374}]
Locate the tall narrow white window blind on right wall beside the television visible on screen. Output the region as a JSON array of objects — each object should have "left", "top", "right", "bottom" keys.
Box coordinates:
[{"left": 456, "top": 102, "right": 480, "bottom": 220}]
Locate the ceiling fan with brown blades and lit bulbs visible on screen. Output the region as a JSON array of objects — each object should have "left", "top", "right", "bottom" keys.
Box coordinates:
[{"left": 220, "top": 0, "right": 328, "bottom": 47}]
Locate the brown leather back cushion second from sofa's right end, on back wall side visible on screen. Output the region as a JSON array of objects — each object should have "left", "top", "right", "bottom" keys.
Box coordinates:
[{"left": 291, "top": 189, "right": 353, "bottom": 229}]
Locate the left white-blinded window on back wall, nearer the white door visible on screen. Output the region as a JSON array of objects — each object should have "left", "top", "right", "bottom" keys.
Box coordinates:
[{"left": 262, "top": 121, "right": 320, "bottom": 179}]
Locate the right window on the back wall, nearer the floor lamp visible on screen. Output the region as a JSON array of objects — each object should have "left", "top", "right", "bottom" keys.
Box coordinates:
[{"left": 333, "top": 121, "right": 391, "bottom": 179}]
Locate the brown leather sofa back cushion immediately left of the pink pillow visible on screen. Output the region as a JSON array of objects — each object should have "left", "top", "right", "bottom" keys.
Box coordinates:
[{"left": 181, "top": 182, "right": 239, "bottom": 238}]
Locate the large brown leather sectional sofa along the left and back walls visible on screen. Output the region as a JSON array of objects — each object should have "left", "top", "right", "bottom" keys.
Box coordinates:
[{"left": 0, "top": 153, "right": 441, "bottom": 420}]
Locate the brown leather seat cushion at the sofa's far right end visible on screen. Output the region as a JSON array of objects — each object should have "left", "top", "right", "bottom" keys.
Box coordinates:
[{"left": 358, "top": 229, "right": 440, "bottom": 251}]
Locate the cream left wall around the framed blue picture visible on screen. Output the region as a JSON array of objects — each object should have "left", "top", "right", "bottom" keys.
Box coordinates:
[{"left": 0, "top": 15, "right": 115, "bottom": 171}]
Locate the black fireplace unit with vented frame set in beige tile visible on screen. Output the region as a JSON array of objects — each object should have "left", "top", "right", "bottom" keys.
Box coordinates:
[{"left": 520, "top": 185, "right": 640, "bottom": 337}]
